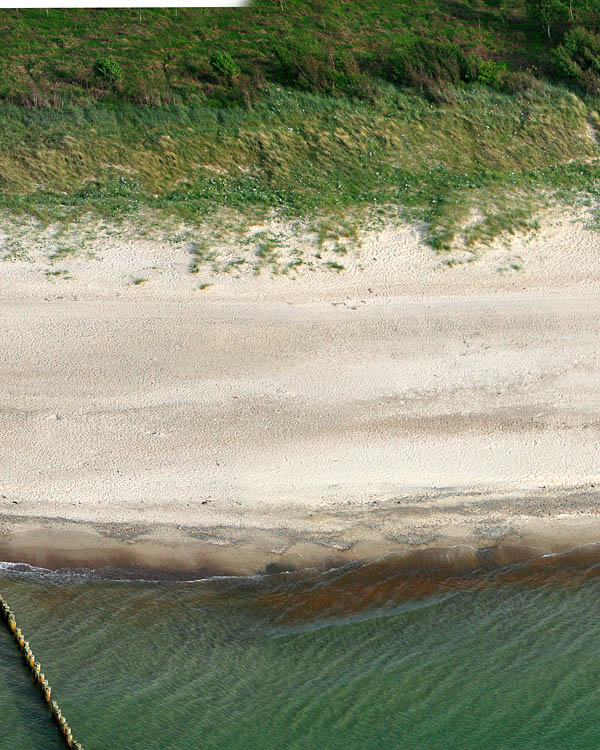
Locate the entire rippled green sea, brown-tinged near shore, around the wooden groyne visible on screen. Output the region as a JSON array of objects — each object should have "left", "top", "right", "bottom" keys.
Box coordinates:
[{"left": 0, "top": 552, "right": 600, "bottom": 750}]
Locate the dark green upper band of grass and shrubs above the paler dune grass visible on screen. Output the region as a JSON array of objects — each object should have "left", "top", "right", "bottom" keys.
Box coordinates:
[{"left": 0, "top": 0, "right": 600, "bottom": 106}]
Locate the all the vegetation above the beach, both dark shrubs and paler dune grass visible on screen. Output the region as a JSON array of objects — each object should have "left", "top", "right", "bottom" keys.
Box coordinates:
[{"left": 0, "top": 0, "right": 600, "bottom": 248}]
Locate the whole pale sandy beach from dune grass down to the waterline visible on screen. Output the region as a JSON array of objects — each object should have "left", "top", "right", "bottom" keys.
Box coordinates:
[{"left": 0, "top": 212, "right": 600, "bottom": 572}]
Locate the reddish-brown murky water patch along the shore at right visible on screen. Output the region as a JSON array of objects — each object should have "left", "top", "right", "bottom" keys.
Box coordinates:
[{"left": 241, "top": 544, "right": 600, "bottom": 623}]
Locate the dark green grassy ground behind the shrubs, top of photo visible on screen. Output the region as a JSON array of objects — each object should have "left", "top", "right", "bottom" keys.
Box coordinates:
[{"left": 0, "top": 0, "right": 551, "bottom": 107}]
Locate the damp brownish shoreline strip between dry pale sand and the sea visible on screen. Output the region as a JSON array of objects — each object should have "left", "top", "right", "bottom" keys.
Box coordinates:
[{"left": 0, "top": 486, "right": 600, "bottom": 580}]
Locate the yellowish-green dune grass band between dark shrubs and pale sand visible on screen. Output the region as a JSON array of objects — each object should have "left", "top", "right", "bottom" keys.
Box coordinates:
[{"left": 0, "top": 84, "right": 600, "bottom": 251}]
